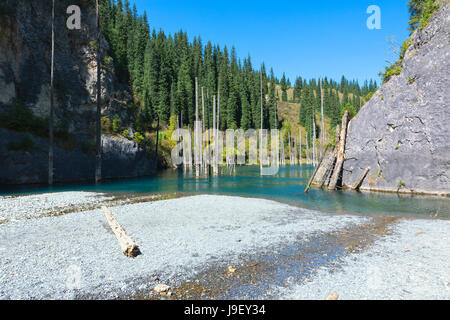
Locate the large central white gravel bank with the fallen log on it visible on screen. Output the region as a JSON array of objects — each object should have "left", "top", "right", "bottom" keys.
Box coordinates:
[{"left": 0, "top": 194, "right": 369, "bottom": 299}]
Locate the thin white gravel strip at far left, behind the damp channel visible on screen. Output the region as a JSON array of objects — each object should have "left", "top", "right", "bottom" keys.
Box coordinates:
[{"left": 0, "top": 191, "right": 112, "bottom": 222}]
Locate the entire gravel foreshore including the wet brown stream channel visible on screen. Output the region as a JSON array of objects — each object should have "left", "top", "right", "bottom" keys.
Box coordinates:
[{"left": 0, "top": 193, "right": 450, "bottom": 299}]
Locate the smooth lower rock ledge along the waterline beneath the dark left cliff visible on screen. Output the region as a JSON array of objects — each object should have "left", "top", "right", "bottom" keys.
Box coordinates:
[{"left": 0, "top": 129, "right": 156, "bottom": 184}]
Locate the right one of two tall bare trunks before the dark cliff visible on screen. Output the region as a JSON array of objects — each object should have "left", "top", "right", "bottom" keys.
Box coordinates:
[{"left": 95, "top": 0, "right": 102, "bottom": 183}]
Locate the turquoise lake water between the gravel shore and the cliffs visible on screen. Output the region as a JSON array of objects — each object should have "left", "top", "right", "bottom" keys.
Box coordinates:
[{"left": 0, "top": 166, "right": 450, "bottom": 218}]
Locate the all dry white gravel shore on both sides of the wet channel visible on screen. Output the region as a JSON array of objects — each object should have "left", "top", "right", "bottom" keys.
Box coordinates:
[{"left": 0, "top": 192, "right": 450, "bottom": 299}]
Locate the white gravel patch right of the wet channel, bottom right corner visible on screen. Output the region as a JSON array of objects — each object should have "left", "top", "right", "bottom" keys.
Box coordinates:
[{"left": 271, "top": 220, "right": 450, "bottom": 300}]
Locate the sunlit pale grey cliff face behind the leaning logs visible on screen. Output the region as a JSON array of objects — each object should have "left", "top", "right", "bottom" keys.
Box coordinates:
[{"left": 343, "top": 3, "right": 450, "bottom": 195}]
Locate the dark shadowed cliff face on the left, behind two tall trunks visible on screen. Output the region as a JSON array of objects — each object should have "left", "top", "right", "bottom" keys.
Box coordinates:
[{"left": 0, "top": 0, "right": 155, "bottom": 184}]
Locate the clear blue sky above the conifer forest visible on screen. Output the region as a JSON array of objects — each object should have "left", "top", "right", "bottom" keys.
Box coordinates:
[{"left": 130, "top": 0, "right": 409, "bottom": 82}]
